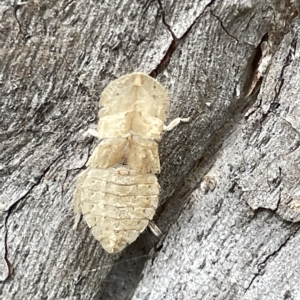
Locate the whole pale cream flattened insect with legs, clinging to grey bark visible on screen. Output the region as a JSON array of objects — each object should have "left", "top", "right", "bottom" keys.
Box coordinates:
[{"left": 73, "top": 73, "right": 189, "bottom": 253}]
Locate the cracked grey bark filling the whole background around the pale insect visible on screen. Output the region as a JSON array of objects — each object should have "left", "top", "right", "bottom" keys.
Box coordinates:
[{"left": 0, "top": 0, "right": 299, "bottom": 299}]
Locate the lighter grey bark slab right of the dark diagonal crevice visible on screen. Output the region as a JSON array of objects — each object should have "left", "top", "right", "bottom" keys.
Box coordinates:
[{"left": 133, "top": 5, "right": 300, "bottom": 300}]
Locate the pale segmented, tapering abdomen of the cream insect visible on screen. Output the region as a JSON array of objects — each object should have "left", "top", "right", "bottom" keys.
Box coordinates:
[{"left": 80, "top": 165, "right": 159, "bottom": 253}]
